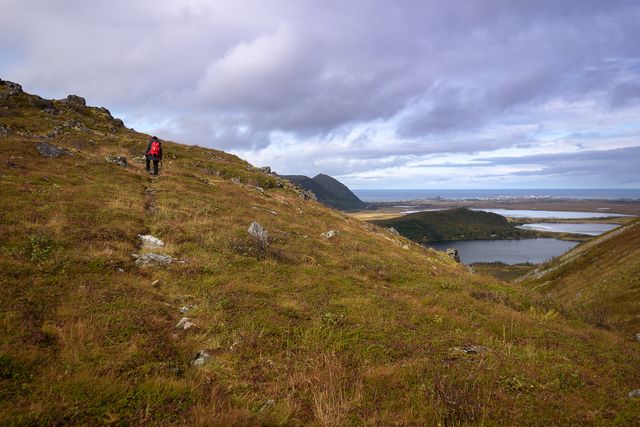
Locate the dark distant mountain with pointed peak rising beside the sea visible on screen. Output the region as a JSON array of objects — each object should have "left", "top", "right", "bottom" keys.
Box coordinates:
[{"left": 282, "top": 174, "right": 367, "bottom": 211}]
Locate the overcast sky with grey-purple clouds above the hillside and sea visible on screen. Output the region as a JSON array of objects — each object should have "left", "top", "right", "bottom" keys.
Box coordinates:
[{"left": 0, "top": 0, "right": 640, "bottom": 188}]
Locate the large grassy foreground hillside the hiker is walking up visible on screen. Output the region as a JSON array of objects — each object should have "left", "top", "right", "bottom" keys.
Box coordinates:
[{"left": 0, "top": 79, "right": 640, "bottom": 426}]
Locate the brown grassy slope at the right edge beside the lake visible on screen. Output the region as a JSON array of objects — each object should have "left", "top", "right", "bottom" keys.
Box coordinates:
[{"left": 521, "top": 220, "right": 640, "bottom": 334}]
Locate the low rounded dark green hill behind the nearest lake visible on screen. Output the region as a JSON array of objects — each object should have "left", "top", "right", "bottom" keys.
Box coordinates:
[{"left": 372, "top": 208, "right": 536, "bottom": 242}]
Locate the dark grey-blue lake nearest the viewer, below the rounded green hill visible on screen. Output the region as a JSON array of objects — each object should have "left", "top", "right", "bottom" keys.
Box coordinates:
[{"left": 425, "top": 239, "right": 578, "bottom": 264}]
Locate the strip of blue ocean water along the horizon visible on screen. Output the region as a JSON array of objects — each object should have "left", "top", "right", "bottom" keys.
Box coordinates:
[{"left": 352, "top": 189, "right": 640, "bottom": 202}]
